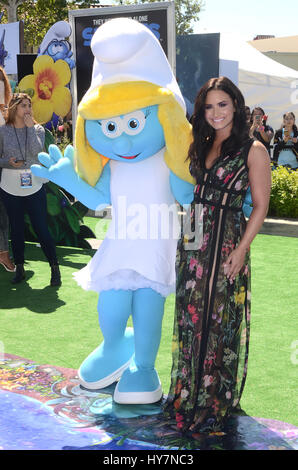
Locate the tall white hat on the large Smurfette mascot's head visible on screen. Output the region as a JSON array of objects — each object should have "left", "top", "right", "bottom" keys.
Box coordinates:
[{"left": 88, "top": 18, "right": 185, "bottom": 110}]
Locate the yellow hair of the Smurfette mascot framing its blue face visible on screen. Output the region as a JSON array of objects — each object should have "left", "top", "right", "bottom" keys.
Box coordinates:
[{"left": 75, "top": 81, "right": 194, "bottom": 186}]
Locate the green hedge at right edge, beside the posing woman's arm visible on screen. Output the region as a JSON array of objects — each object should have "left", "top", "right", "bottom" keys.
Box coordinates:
[{"left": 268, "top": 166, "right": 298, "bottom": 219}]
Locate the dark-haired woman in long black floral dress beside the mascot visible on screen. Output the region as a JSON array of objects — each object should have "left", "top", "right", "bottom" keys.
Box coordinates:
[{"left": 164, "top": 77, "right": 271, "bottom": 433}]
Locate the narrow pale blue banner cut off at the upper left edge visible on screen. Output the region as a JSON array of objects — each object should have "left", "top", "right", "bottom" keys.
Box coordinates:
[{"left": 0, "top": 21, "right": 21, "bottom": 75}]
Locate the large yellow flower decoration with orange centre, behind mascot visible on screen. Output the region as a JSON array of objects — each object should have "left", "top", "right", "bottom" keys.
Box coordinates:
[{"left": 18, "top": 55, "right": 72, "bottom": 124}]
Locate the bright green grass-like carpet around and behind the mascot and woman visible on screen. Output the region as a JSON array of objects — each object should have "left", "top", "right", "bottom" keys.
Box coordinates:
[{"left": 0, "top": 218, "right": 298, "bottom": 425}]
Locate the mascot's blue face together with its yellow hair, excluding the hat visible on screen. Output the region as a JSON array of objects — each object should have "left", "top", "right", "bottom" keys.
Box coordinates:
[{"left": 75, "top": 80, "right": 193, "bottom": 186}]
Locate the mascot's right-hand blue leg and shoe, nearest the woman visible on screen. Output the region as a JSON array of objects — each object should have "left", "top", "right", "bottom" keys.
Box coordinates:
[{"left": 114, "top": 289, "right": 165, "bottom": 404}]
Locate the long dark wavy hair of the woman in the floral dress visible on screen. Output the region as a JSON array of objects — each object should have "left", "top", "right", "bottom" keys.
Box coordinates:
[{"left": 188, "top": 77, "right": 249, "bottom": 176}]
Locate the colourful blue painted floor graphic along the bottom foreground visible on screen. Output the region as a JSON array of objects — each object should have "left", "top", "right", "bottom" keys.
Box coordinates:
[{"left": 0, "top": 354, "right": 298, "bottom": 450}]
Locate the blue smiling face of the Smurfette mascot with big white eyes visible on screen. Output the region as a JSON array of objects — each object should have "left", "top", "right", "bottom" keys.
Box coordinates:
[{"left": 85, "top": 105, "right": 165, "bottom": 163}]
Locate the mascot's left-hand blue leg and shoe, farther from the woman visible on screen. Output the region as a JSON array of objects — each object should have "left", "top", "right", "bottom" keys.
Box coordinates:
[{"left": 78, "top": 290, "right": 134, "bottom": 390}]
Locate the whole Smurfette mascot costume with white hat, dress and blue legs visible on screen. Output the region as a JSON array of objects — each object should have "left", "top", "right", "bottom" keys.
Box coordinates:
[{"left": 32, "top": 18, "right": 193, "bottom": 404}]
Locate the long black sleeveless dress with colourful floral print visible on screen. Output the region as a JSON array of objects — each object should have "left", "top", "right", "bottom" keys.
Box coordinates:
[{"left": 164, "top": 141, "right": 252, "bottom": 433}]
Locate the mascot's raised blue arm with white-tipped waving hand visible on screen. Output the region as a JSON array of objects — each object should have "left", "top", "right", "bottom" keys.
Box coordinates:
[{"left": 31, "top": 145, "right": 111, "bottom": 210}]
